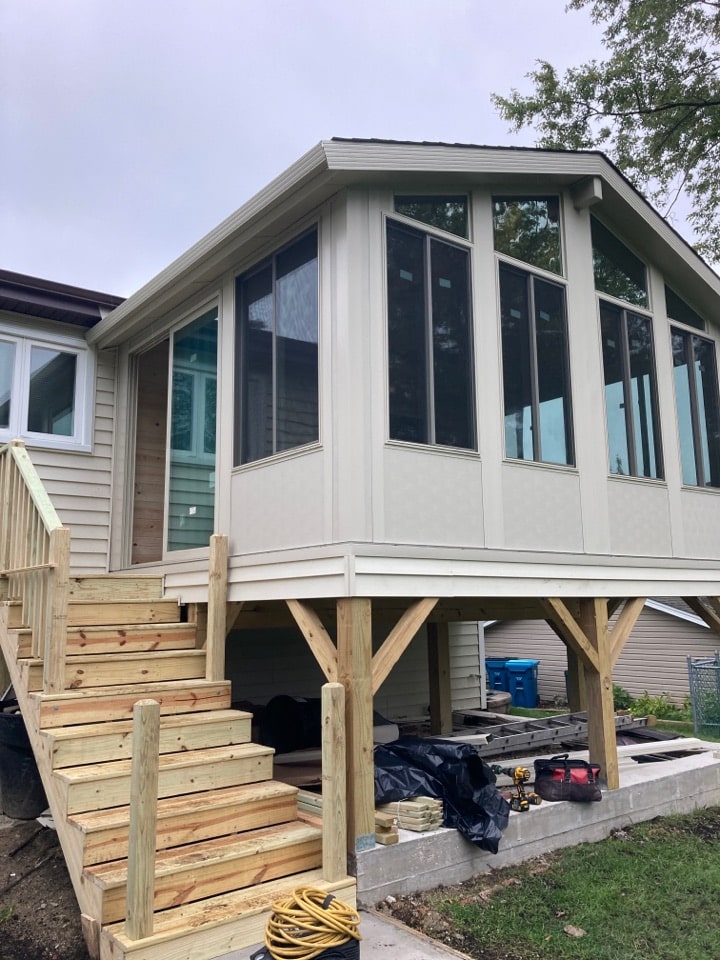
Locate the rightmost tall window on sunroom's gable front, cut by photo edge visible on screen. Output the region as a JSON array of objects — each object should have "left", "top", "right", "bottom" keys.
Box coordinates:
[{"left": 672, "top": 327, "right": 720, "bottom": 487}]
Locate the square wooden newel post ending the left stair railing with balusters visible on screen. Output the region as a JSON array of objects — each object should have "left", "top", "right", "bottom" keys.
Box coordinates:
[{"left": 43, "top": 527, "right": 70, "bottom": 693}]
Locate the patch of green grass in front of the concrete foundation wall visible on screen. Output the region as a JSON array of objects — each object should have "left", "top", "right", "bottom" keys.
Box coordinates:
[{"left": 424, "top": 807, "right": 720, "bottom": 960}]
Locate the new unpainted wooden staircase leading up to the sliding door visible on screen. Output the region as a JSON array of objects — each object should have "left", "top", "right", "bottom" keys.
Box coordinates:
[{"left": 0, "top": 576, "right": 355, "bottom": 960}]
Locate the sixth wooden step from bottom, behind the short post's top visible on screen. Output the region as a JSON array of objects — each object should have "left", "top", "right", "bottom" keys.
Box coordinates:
[{"left": 28, "top": 680, "right": 232, "bottom": 729}]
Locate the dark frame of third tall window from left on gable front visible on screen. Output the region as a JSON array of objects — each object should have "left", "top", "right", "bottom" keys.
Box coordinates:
[{"left": 597, "top": 294, "right": 665, "bottom": 481}]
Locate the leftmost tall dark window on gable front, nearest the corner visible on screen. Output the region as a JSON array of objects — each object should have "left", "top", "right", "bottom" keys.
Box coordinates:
[{"left": 387, "top": 221, "right": 475, "bottom": 449}]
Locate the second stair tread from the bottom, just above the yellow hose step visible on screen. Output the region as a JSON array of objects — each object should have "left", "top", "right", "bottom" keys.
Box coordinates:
[{"left": 84, "top": 820, "right": 322, "bottom": 890}]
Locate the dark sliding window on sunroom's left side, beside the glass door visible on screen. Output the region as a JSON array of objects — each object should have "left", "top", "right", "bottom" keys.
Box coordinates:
[{"left": 235, "top": 230, "right": 319, "bottom": 464}]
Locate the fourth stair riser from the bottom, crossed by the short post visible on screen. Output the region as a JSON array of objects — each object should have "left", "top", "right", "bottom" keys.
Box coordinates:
[{"left": 56, "top": 755, "right": 273, "bottom": 814}]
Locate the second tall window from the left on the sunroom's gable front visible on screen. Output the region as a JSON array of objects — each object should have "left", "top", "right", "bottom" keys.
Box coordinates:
[{"left": 500, "top": 263, "right": 574, "bottom": 464}]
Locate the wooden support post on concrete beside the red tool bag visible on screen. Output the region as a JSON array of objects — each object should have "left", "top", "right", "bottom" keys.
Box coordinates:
[{"left": 579, "top": 597, "right": 620, "bottom": 790}]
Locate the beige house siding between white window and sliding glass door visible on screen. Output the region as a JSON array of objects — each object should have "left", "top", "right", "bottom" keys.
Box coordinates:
[{"left": 29, "top": 351, "right": 115, "bottom": 573}]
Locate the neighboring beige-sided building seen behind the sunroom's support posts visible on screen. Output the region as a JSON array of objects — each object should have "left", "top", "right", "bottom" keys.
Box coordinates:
[{"left": 485, "top": 599, "right": 719, "bottom": 704}]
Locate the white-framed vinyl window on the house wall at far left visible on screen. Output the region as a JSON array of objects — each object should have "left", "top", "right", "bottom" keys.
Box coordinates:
[{"left": 0, "top": 325, "right": 93, "bottom": 450}]
